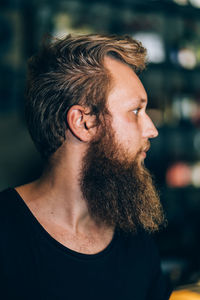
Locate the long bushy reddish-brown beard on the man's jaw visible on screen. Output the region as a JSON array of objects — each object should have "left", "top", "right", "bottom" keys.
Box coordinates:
[{"left": 80, "top": 126, "right": 165, "bottom": 232}]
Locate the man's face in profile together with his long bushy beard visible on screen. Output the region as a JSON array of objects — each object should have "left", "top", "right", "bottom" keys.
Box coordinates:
[{"left": 80, "top": 59, "right": 164, "bottom": 232}]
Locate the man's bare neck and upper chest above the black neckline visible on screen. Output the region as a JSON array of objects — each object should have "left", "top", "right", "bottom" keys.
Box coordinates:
[{"left": 16, "top": 137, "right": 113, "bottom": 254}]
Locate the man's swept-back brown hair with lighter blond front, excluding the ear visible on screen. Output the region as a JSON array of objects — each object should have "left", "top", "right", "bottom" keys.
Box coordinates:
[{"left": 26, "top": 35, "right": 146, "bottom": 158}]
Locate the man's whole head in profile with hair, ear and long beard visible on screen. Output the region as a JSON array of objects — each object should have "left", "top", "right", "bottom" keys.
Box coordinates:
[{"left": 26, "top": 35, "right": 166, "bottom": 231}]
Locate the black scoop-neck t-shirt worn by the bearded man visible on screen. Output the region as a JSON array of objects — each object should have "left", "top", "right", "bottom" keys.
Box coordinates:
[{"left": 0, "top": 189, "right": 170, "bottom": 300}]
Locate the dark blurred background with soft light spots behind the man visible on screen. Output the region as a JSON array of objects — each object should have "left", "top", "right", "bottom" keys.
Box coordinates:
[{"left": 0, "top": 0, "right": 200, "bottom": 286}]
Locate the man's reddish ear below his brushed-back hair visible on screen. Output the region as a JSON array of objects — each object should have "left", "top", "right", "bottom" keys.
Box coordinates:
[{"left": 67, "top": 105, "right": 96, "bottom": 142}]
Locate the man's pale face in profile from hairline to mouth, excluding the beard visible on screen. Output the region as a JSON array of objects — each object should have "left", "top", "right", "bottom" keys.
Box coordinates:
[{"left": 102, "top": 57, "right": 158, "bottom": 164}]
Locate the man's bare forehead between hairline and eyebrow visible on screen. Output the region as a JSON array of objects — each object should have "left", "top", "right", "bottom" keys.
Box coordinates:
[{"left": 104, "top": 57, "right": 147, "bottom": 107}]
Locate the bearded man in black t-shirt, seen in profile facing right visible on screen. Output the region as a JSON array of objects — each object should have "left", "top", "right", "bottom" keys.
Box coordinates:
[{"left": 0, "top": 35, "right": 169, "bottom": 300}]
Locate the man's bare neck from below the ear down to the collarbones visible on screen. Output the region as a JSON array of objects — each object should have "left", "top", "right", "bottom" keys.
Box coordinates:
[{"left": 16, "top": 142, "right": 99, "bottom": 233}]
